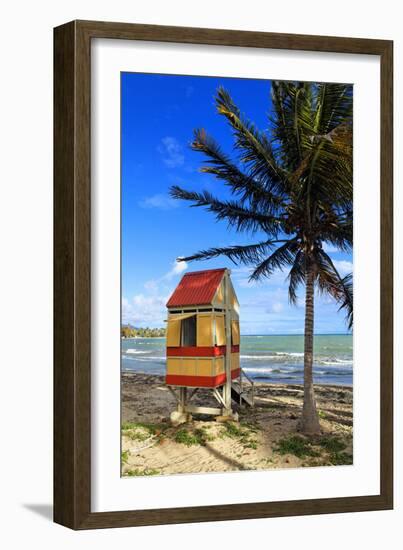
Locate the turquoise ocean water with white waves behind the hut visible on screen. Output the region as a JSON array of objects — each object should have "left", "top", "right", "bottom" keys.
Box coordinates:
[{"left": 122, "top": 334, "right": 353, "bottom": 385}]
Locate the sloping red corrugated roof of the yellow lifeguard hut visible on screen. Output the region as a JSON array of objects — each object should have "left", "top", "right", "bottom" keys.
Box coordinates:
[{"left": 167, "top": 268, "right": 225, "bottom": 307}]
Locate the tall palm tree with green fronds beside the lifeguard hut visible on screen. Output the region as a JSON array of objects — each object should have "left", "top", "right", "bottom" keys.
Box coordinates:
[{"left": 171, "top": 81, "right": 353, "bottom": 434}]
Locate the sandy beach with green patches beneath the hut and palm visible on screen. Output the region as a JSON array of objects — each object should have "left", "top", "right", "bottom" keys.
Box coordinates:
[{"left": 122, "top": 373, "right": 353, "bottom": 476}]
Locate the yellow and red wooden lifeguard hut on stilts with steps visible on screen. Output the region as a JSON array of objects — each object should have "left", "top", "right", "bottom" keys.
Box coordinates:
[{"left": 166, "top": 269, "right": 253, "bottom": 423}]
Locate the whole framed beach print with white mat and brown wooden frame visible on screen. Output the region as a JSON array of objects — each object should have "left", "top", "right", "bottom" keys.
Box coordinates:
[{"left": 54, "top": 21, "right": 393, "bottom": 529}]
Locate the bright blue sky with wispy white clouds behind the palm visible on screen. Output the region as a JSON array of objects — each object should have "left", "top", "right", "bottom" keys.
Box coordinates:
[{"left": 122, "top": 73, "right": 352, "bottom": 334}]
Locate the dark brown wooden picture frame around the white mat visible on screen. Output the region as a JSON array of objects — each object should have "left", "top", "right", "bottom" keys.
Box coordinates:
[{"left": 54, "top": 21, "right": 393, "bottom": 529}]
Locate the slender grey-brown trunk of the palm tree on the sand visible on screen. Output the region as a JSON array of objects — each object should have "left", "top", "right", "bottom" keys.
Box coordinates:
[{"left": 299, "top": 265, "right": 320, "bottom": 434}]
